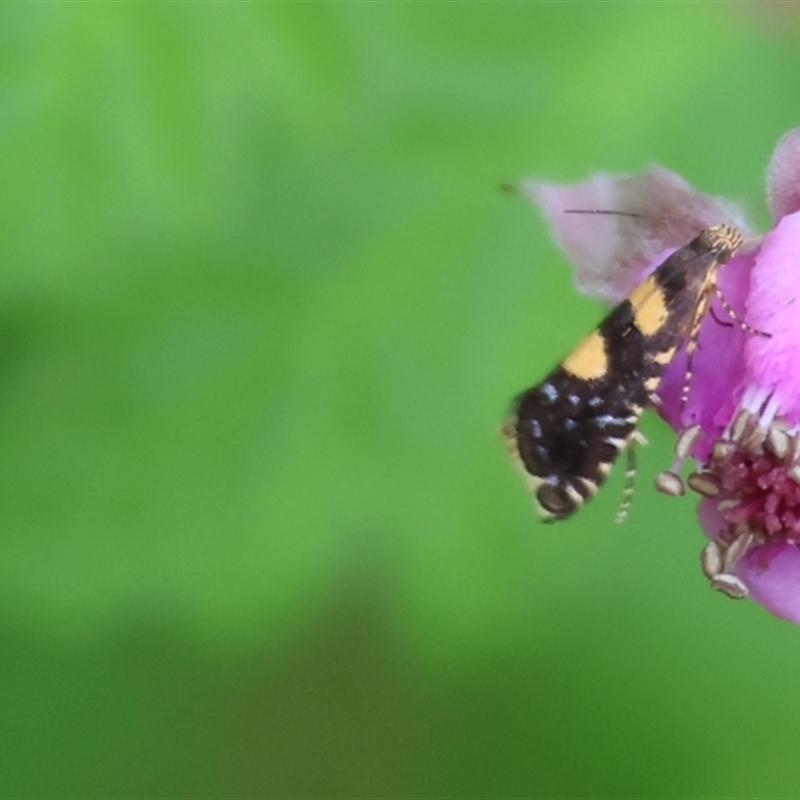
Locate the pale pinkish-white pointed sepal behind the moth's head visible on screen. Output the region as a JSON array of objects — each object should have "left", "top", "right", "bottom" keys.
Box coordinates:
[{"left": 519, "top": 167, "right": 747, "bottom": 302}]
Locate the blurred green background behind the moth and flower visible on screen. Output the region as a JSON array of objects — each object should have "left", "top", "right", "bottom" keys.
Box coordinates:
[{"left": 0, "top": 3, "right": 800, "bottom": 797}]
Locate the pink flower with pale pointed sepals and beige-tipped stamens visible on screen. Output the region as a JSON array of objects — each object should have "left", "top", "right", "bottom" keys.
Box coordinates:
[{"left": 520, "top": 128, "right": 800, "bottom": 623}]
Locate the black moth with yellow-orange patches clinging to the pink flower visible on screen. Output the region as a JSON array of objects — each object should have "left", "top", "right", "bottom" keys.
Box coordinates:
[{"left": 503, "top": 225, "right": 746, "bottom": 521}]
